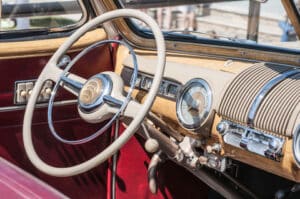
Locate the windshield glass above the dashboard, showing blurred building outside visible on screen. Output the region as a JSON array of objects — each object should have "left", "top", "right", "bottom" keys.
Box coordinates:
[{"left": 122, "top": 0, "right": 300, "bottom": 51}]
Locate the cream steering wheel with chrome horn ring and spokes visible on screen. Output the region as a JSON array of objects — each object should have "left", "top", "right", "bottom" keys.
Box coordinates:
[{"left": 23, "top": 9, "right": 165, "bottom": 177}]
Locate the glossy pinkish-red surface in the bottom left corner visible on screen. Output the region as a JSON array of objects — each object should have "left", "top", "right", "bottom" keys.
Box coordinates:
[{"left": 0, "top": 158, "right": 66, "bottom": 199}]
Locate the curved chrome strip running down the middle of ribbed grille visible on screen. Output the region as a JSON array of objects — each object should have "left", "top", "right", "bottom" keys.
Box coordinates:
[{"left": 247, "top": 68, "right": 300, "bottom": 127}]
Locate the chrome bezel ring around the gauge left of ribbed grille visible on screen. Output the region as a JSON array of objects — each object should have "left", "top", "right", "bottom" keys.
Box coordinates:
[{"left": 176, "top": 78, "right": 212, "bottom": 130}]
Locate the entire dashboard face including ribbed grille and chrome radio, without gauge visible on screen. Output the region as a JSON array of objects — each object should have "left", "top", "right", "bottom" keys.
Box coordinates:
[{"left": 116, "top": 51, "right": 300, "bottom": 182}]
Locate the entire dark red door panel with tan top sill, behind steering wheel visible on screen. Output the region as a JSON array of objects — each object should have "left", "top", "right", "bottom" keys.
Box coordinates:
[{"left": 0, "top": 30, "right": 113, "bottom": 198}]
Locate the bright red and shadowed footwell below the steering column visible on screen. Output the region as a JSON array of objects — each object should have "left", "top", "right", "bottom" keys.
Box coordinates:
[{"left": 107, "top": 126, "right": 208, "bottom": 199}]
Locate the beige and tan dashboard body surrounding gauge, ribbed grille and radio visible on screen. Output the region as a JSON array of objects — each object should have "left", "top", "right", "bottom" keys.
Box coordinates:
[{"left": 115, "top": 47, "right": 300, "bottom": 182}]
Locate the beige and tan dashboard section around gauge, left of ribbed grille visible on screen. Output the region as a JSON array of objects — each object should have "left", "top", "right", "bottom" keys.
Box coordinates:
[{"left": 115, "top": 47, "right": 244, "bottom": 137}]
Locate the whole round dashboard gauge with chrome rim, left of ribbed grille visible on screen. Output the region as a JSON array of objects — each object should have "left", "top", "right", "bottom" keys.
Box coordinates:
[{"left": 176, "top": 79, "right": 212, "bottom": 129}]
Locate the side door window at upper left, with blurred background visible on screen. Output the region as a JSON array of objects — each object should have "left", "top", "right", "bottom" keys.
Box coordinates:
[{"left": 0, "top": 0, "right": 85, "bottom": 33}]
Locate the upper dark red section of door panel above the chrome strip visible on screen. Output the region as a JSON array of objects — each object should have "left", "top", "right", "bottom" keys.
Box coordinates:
[{"left": 0, "top": 37, "right": 112, "bottom": 126}]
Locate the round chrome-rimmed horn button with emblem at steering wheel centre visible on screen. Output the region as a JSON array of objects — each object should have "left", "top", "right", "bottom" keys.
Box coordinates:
[{"left": 78, "top": 74, "right": 112, "bottom": 112}]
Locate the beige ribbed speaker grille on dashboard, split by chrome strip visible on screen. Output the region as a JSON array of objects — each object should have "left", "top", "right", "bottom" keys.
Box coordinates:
[{"left": 219, "top": 63, "right": 300, "bottom": 136}]
